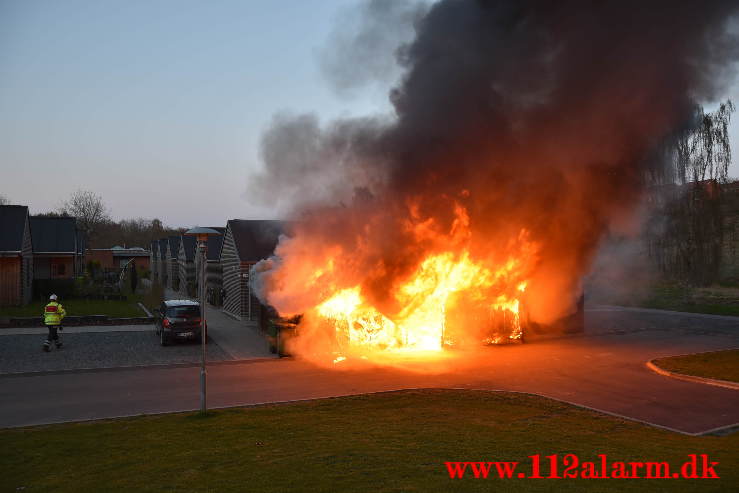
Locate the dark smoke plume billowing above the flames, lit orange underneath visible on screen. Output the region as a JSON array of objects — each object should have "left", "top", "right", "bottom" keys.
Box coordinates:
[{"left": 254, "top": 0, "right": 739, "bottom": 321}]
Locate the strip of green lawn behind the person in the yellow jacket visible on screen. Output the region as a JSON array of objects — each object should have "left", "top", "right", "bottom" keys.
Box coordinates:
[{"left": 0, "top": 296, "right": 146, "bottom": 318}]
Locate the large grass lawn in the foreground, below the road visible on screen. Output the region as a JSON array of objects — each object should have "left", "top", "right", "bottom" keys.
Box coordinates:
[{"left": 0, "top": 390, "right": 739, "bottom": 493}]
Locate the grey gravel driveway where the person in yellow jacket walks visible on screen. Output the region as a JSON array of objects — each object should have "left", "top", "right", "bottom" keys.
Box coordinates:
[{"left": 0, "top": 327, "right": 231, "bottom": 374}]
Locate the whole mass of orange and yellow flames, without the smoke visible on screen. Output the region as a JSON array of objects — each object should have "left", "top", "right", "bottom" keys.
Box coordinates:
[{"left": 258, "top": 197, "right": 537, "bottom": 363}]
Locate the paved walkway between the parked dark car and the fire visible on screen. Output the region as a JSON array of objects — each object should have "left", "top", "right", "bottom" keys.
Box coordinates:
[{"left": 164, "top": 289, "right": 277, "bottom": 360}]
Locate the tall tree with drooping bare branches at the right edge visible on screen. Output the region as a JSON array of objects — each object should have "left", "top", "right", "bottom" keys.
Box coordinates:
[{"left": 647, "top": 101, "right": 734, "bottom": 285}]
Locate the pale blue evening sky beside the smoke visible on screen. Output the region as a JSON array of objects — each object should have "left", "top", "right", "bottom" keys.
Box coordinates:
[{"left": 0, "top": 0, "right": 739, "bottom": 227}]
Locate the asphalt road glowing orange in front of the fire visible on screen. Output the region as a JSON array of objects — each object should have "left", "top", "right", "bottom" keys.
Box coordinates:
[{"left": 0, "top": 308, "right": 739, "bottom": 433}]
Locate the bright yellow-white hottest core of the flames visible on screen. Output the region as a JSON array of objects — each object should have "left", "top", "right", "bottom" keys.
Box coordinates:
[{"left": 315, "top": 244, "right": 527, "bottom": 363}]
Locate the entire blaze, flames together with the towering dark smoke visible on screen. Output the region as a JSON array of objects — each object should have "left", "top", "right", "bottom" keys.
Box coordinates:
[{"left": 251, "top": 0, "right": 737, "bottom": 366}]
